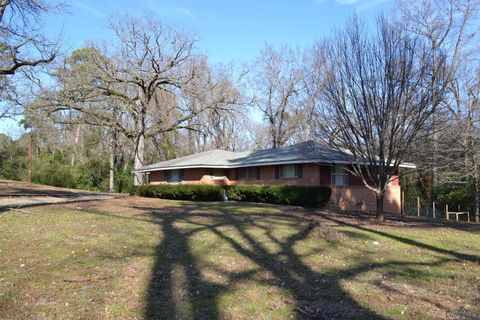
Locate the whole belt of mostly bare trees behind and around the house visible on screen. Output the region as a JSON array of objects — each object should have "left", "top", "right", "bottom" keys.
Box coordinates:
[{"left": 0, "top": 0, "right": 480, "bottom": 221}]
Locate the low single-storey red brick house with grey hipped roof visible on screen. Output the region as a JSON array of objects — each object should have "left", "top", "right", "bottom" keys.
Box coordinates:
[{"left": 134, "top": 141, "right": 415, "bottom": 214}]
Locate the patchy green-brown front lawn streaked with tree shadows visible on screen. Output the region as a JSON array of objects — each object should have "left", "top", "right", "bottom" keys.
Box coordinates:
[{"left": 0, "top": 197, "right": 480, "bottom": 319}]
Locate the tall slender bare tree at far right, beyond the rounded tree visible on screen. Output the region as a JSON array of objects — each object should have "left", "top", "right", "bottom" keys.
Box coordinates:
[{"left": 393, "top": 0, "right": 480, "bottom": 195}]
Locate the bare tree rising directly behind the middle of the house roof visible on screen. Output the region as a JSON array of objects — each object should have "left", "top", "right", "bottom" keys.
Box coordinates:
[{"left": 252, "top": 46, "right": 308, "bottom": 148}]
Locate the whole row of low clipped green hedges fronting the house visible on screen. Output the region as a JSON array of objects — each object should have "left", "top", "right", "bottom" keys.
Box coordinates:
[{"left": 135, "top": 184, "right": 331, "bottom": 208}]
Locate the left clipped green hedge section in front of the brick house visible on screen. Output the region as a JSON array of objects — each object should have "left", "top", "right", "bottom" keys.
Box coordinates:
[{"left": 134, "top": 184, "right": 223, "bottom": 201}]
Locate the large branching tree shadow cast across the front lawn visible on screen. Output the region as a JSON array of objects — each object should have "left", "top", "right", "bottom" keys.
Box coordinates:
[{"left": 89, "top": 204, "right": 469, "bottom": 319}]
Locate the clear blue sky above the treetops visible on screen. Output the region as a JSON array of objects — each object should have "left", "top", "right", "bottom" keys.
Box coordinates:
[{"left": 0, "top": 0, "right": 394, "bottom": 137}]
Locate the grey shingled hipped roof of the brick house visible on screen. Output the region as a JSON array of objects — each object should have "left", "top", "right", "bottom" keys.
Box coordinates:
[{"left": 134, "top": 141, "right": 415, "bottom": 172}]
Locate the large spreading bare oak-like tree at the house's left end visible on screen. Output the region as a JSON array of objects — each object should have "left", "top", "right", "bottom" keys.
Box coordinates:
[{"left": 36, "top": 16, "right": 199, "bottom": 184}]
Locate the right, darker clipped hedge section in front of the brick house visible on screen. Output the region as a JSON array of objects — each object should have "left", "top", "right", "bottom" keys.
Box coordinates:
[{"left": 227, "top": 185, "right": 331, "bottom": 208}]
